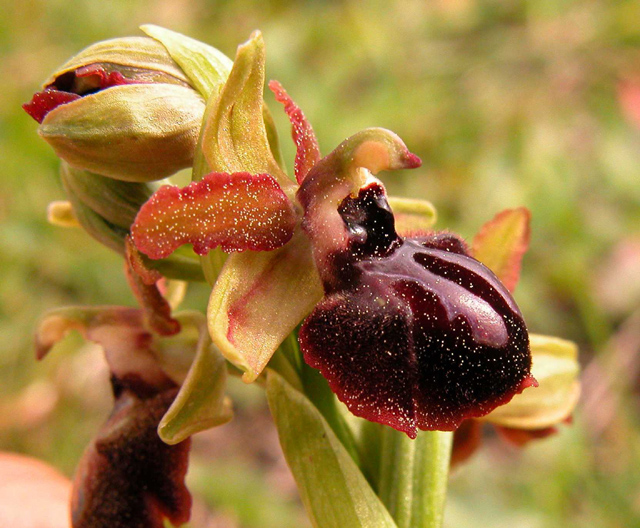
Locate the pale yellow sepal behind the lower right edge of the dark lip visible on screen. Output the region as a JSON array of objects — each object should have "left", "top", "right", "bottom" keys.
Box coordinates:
[{"left": 485, "top": 334, "right": 580, "bottom": 430}]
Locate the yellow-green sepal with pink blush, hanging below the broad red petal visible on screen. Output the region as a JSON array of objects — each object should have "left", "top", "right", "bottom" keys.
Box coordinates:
[{"left": 207, "top": 230, "right": 322, "bottom": 382}]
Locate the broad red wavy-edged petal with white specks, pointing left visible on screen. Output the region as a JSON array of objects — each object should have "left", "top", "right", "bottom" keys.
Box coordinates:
[{"left": 131, "top": 172, "right": 296, "bottom": 259}]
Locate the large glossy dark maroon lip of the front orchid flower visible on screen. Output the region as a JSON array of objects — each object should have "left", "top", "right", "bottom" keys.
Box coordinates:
[{"left": 300, "top": 184, "right": 535, "bottom": 438}]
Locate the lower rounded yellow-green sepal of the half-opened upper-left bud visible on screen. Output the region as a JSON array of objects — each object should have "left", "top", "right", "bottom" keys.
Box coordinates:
[{"left": 38, "top": 84, "right": 204, "bottom": 182}]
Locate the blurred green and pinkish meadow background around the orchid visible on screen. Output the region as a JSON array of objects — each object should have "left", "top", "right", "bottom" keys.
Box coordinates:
[{"left": 0, "top": 0, "right": 640, "bottom": 528}]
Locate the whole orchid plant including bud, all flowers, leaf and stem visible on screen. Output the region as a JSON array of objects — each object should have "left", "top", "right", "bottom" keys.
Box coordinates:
[{"left": 25, "top": 26, "right": 579, "bottom": 527}]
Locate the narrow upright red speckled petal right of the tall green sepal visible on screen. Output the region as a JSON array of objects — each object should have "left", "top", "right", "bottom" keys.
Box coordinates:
[{"left": 269, "top": 81, "right": 320, "bottom": 183}]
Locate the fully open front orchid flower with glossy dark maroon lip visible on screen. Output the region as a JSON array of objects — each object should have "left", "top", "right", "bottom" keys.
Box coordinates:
[{"left": 131, "top": 34, "right": 572, "bottom": 438}]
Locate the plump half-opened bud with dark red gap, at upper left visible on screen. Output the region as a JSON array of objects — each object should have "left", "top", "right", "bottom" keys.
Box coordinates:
[{"left": 24, "top": 37, "right": 204, "bottom": 182}]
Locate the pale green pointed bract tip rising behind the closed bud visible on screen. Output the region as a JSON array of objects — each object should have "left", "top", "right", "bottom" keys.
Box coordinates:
[{"left": 140, "top": 24, "right": 233, "bottom": 101}]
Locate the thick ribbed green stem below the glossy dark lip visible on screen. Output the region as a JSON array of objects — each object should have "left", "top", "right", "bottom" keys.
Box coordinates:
[{"left": 378, "top": 428, "right": 453, "bottom": 528}]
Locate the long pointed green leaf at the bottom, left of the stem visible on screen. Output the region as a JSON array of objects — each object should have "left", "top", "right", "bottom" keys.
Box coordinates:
[{"left": 267, "top": 370, "right": 396, "bottom": 528}]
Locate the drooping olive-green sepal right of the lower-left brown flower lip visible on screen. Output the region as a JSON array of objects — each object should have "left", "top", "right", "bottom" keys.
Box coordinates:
[{"left": 156, "top": 312, "right": 233, "bottom": 445}]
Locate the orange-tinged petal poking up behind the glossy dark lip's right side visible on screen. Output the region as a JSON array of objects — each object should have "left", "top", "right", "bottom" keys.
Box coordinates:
[{"left": 472, "top": 207, "right": 531, "bottom": 292}]
